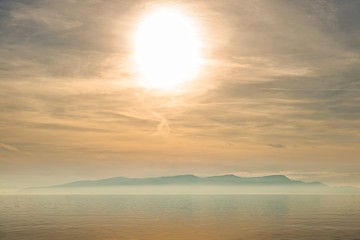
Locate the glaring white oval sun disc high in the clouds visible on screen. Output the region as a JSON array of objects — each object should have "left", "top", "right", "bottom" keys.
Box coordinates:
[{"left": 134, "top": 8, "right": 202, "bottom": 90}]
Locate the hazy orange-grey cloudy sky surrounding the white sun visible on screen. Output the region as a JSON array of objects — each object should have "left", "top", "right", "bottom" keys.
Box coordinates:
[{"left": 0, "top": 0, "right": 360, "bottom": 192}]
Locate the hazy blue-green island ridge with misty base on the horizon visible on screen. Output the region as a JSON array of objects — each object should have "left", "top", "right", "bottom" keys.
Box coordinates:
[{"left": 21, "top": 174, "right": 360, "bottom": 194}]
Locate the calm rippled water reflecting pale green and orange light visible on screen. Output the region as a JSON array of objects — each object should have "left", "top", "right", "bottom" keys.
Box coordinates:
[{"left": 0, "top": 195, "right": 360, "bottom": 240}]
